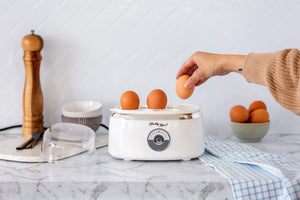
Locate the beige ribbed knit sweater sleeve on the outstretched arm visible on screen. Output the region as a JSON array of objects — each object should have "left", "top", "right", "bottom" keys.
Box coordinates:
[{"left": 243, "top": 49, "right": 300, "bottom": 115}]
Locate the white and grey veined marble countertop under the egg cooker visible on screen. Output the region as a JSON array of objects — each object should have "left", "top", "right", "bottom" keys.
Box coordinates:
[{"left": 0, "top": 132, "right": 300, "bottom": 200}]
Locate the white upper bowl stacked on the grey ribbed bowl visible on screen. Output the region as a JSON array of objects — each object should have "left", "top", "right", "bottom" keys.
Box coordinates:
[{"left": 62, "top": 101, "right": 102, "bottom": 118}]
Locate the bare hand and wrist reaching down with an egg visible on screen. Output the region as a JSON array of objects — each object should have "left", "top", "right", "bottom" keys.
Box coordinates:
[{"left": 176, "top": 52, "right": 245, "bottom": 88}]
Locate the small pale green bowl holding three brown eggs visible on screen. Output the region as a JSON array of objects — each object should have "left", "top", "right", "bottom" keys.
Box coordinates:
[{"left": 230, "top": 121, "right": 270, "bottom": 142}]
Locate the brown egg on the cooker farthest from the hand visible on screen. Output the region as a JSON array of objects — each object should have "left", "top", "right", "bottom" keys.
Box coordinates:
[{"left": 120, "top": 90, "right": 140, "bottom": 110}]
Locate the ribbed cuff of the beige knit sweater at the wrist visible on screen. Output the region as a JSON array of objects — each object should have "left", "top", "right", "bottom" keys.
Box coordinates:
[{"left": 243, "top": 53, "right": 273, "bottom": 86}]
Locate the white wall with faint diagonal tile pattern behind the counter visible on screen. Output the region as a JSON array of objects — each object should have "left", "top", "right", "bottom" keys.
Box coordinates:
[{"left": 0, "top": 0, "right": 300, "bottom": 134}]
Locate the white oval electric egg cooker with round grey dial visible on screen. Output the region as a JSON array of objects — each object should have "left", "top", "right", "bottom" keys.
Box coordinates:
[{"left": 108, "top": 103, "right": 204, "bottom": 160}]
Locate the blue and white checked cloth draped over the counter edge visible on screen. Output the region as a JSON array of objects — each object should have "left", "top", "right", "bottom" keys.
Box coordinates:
[{"left": 199, "top": 135, "right": 300, "bottom": 200}]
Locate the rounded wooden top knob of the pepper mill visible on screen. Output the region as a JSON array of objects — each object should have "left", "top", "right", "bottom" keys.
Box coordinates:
[{"left": 22, "top": 30, "right": 44, "bottom": 51}]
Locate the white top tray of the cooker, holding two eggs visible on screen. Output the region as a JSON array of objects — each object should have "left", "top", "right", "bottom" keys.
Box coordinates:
[{"left": 111, "top": 103, "right": 200, "bottom": 115}]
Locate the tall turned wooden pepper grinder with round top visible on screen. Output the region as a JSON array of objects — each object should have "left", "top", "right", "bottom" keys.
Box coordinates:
[{"left": 22, "top": 30, "right": 44, "bottom": 137}]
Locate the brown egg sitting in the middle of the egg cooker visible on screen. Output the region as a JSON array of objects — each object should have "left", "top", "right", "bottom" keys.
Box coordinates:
[{"left": 147, "top": 89, "right": 168, "bottom": 109}]
